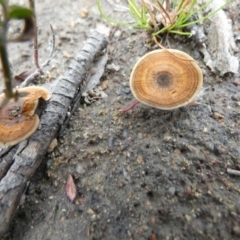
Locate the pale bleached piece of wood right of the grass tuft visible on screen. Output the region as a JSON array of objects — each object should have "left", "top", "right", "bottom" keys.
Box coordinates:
[{"left": 199, "top": 0, "right": 239, "bottom": 76}]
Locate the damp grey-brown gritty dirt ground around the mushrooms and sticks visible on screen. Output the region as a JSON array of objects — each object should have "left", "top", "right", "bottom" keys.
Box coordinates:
[{"left": 3, "top": 0, "right": 240, "bottom": 240}]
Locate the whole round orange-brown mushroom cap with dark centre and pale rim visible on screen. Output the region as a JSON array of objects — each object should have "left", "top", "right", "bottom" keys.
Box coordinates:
[{"left": 130, "top": 49, "right": 203, "bottom": 110}]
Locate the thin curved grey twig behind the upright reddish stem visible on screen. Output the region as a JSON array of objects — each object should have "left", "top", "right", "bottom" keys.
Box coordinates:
[{"left": 21, "top": 25, "right": 57, "bottom": 87}]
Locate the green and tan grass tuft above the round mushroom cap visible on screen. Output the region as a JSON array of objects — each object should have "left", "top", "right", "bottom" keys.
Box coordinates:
[{"left": 97, "top": 0, "right": 231, "bottom": 36}]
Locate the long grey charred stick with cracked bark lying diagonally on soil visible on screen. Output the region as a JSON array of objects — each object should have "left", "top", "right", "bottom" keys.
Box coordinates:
[{"left": 0, "top": 32, "right": 107, "bottom": 238}]
